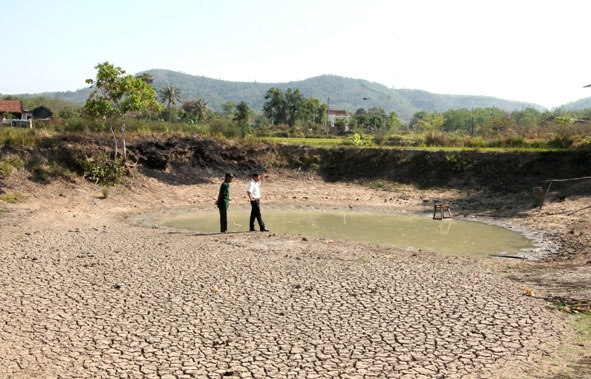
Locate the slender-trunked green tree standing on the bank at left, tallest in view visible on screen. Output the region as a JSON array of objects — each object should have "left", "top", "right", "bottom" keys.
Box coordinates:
[{"left": 83, "top": 62, "right": 160, "bottom": 161}]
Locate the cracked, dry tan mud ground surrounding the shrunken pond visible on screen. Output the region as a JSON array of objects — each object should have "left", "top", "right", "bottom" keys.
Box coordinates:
[{"left": 0, "top": 172, "right": 591, "bottom": 378}]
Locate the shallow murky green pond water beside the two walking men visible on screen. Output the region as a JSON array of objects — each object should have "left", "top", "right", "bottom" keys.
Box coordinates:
[{"left": 154, "top": 209, "right": 533, "bottom": 255}]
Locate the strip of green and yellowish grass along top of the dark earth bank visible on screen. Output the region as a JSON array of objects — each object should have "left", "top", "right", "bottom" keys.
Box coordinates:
[{"left": 0, "top": 124, "right": 591, "bottom": 152}]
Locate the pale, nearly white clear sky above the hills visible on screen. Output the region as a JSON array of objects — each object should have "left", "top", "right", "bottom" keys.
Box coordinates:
[{"left": 0, "top": 0, "right": 591, "bottom": 109}]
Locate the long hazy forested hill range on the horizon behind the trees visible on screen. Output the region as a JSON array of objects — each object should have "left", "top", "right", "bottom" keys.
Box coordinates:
[{"left": 23, "top": 69, "right": 545, "bottom": 120}]
